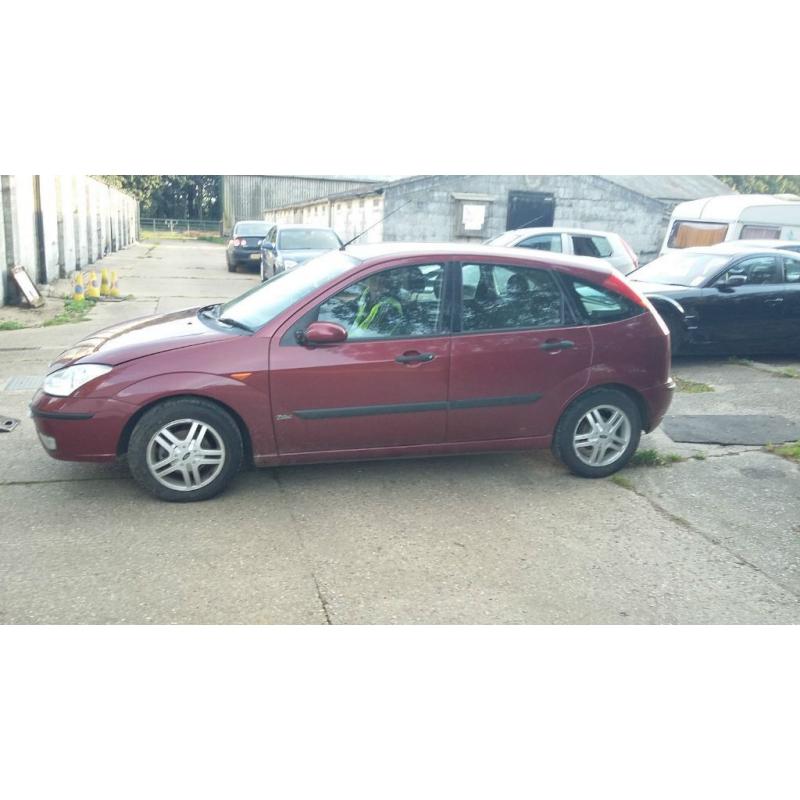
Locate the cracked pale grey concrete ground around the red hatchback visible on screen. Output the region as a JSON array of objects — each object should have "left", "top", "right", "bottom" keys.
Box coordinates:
[{"left": 0, "top": 241, "right": 800, "bottom": 624}]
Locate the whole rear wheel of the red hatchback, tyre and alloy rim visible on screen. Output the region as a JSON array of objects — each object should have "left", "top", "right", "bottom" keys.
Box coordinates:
[{"left": 553, "top": 389, "right": 642, "bottom": 478}]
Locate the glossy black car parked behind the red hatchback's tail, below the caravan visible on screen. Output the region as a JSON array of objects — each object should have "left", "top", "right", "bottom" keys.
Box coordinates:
[{"left": 628, "top": 243, "right": 800, "bottom": 355}]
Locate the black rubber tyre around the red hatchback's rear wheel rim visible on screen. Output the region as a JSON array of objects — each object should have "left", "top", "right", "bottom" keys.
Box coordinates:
[{"left": 553, "top": 389, "right": 642, "bottom": 478}]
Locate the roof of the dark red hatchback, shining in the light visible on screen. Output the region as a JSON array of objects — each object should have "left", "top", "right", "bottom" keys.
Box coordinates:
[{"left": 345, "top": 242, "right": 611, "bottom": 272}]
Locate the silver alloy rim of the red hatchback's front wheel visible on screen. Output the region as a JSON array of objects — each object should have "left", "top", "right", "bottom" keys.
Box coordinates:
[{"left": 146, "top": 419, "right": 225, "bottom": 492}]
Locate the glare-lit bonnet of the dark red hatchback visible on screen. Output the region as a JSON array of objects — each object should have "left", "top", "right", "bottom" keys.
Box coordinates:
[{"left": 49, "top": 308, "right": 231, "bottom": 372}]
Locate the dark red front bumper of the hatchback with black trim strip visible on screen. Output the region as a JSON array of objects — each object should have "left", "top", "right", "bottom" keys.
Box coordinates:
[{"left": 30, "top": 389, "right": 136, "bottom": 461}]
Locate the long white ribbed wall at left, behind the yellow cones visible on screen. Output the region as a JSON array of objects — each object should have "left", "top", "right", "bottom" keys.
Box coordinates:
[{"left": 0, "top": 175, "right": 139, "bottom": 305}]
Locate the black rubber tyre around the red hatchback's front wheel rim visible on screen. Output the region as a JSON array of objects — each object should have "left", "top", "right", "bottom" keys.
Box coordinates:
[{"left": 128, "top": 397, "right": 244, "bottom": 503}]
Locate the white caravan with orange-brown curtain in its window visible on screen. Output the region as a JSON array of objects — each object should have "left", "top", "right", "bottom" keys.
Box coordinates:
[{"left": 660, "top": 194, "right": 800, "bottom": 255}]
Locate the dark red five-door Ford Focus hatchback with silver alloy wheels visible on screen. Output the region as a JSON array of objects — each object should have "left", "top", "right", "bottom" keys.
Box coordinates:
[{"left": 31, "top": 245, "right": 674, "bottom": 501}]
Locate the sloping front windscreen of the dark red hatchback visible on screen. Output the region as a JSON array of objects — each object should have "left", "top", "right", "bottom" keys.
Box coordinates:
[{"left": 217, "top": 250, "right": 361, "bottom": 330}]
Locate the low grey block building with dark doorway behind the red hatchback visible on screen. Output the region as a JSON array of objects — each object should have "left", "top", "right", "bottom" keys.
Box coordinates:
[{"left": 267, "top": 175, "right": 735, "bottom": 263}]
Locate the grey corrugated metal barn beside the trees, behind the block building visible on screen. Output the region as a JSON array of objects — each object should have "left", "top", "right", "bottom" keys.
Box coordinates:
[{"left": 222, "top": 175, "right": 385, "bottom": 235}]
